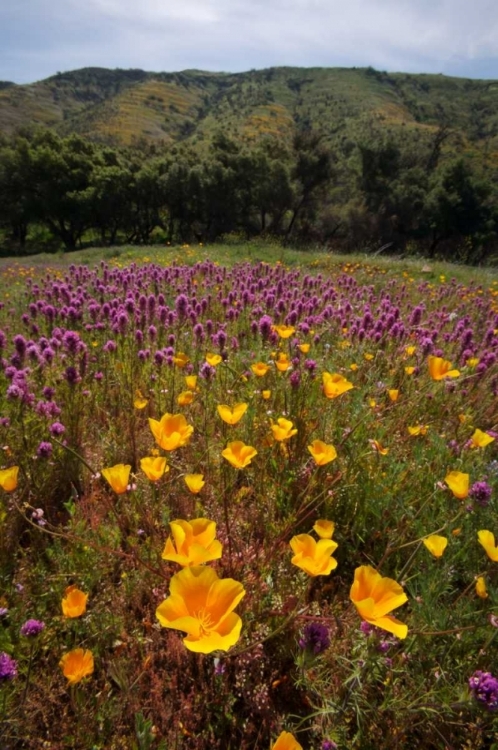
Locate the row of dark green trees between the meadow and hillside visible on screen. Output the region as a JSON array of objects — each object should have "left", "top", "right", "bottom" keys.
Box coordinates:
[{"left": 0, "top": 127, "right": 498, "bottom": 263}]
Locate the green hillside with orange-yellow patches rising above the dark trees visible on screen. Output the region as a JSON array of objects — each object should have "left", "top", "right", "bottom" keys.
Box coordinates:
[{"left": 0, "top": 67, "right": 498, "bottom": 163}]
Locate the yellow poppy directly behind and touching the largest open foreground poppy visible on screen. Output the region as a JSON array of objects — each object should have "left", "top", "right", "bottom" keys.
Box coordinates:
[{"left": 161, "top": 518, "right": 222, "bottom": 567}]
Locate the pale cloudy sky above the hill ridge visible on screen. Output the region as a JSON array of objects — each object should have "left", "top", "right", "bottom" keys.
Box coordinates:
[{"left": 0, "top": 0, "right": 498, "bottom": 83}]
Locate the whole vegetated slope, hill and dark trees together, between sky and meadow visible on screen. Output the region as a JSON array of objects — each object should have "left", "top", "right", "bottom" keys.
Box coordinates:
[{"left": 0, "top": 67, "right": 498, "bottom": 263}]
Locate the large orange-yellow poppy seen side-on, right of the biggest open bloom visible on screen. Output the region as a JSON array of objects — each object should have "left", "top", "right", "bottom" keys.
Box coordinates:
[{"left": 350, "top": 565, "right": 408, "bottom": 638}]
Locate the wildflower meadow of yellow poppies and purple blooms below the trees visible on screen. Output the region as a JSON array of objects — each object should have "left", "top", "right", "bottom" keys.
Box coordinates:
[{"left": 0, "top": 248, "right": 498, "bottom": 750}]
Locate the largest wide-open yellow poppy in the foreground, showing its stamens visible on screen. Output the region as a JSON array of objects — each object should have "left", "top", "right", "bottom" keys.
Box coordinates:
[{"left": 156, "top": 566, "right": 246, "bottom": 654}]
